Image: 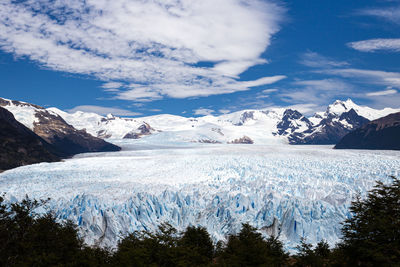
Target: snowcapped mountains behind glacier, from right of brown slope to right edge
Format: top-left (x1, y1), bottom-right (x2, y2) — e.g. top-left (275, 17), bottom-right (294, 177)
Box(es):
top-left (48, 99), bottom-right (400, 144)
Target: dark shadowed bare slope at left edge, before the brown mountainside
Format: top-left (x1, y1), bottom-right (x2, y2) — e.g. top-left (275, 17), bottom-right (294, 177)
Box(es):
top-left (0, 107), bottom-right (60, 172)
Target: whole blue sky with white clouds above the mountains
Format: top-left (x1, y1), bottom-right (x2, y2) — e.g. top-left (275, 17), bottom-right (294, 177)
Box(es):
top-left (0, 0), bottom-right (400, 117)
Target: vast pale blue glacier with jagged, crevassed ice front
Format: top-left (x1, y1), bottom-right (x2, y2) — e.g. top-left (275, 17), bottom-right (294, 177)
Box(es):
top-left (0, 139), bottom-right (400, 251)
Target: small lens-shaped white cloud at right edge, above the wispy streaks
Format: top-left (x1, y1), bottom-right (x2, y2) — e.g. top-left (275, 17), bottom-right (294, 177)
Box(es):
top-left (348, 39), bottom-right (400, 52)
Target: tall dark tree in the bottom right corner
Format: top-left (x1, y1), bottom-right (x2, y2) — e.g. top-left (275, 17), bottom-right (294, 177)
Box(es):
top-left (339, 177), bottom-right (400, 266)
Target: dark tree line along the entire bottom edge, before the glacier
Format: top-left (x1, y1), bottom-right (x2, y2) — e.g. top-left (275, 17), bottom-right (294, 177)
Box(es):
top-left (0, 178), bottom-right (400, 267)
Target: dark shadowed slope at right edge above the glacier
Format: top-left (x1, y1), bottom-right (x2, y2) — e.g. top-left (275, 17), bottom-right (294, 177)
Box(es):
top-left (335, 112), bottom-right (400, 150)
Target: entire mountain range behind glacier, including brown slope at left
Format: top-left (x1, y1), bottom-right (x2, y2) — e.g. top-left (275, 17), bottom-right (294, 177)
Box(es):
top-left (0, 98), bottom-right (400, 148)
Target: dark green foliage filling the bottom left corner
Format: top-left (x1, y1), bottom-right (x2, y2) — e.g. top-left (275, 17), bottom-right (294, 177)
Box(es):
top-left (0, 197), bottom-right (107, 266)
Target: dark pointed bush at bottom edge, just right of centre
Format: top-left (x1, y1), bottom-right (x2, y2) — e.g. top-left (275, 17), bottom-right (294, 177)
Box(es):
top-left (219, 224), bottom-right (287, 266)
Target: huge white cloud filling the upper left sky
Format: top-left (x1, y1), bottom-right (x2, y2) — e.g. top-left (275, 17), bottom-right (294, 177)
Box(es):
top-left (0, 0), bottom-right (284, 101)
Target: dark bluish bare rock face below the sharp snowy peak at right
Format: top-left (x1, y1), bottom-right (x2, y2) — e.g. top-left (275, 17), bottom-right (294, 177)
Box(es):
top-left (289, 109), bottom-right (369, 145)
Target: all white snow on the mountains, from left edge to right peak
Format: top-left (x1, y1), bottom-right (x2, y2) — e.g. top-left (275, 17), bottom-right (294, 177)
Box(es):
top-left (5, 99), bottom-right (400, 145)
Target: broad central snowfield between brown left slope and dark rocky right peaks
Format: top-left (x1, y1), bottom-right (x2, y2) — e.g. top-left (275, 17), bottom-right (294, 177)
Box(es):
top-left (49, 108), bottom-right (287, 144)
